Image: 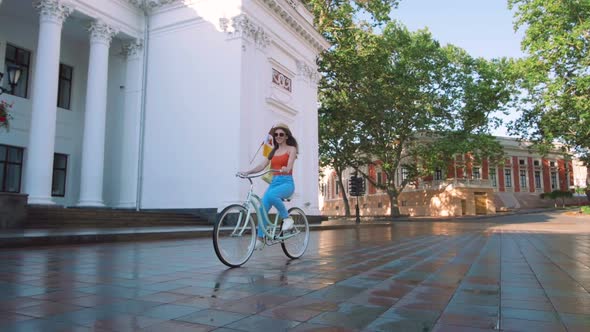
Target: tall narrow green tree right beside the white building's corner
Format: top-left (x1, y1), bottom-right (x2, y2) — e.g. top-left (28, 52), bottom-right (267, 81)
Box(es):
top-left (304, 0), bottom-right (398, 216)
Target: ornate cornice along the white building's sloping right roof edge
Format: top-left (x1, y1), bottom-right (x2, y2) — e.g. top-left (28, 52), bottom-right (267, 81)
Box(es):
top-left (260, 0), bottom-right (330, 53)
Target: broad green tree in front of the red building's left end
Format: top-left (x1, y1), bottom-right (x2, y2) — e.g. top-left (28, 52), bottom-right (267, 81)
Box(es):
top-left (354, 22), bottom-right (511, 216)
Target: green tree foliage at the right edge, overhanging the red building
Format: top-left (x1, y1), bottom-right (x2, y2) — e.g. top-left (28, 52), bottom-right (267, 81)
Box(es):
top-left (508, 0), bottom-right (590, 155)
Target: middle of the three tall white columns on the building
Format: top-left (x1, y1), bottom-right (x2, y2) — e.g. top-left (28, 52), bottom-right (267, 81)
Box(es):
top-left (78, 21), bottom-right (116, 206)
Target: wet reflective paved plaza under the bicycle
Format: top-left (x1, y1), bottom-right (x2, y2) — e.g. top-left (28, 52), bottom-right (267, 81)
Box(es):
top-left (0, 212), bottom-right (590, 332)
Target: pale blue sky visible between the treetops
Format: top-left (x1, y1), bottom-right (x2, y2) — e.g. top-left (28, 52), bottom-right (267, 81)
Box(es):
top-left (390, 0), bottom-right (524, 136)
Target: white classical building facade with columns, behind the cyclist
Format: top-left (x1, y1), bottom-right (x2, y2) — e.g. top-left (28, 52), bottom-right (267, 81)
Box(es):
top-left (0, 0), bottom-right (329, 215)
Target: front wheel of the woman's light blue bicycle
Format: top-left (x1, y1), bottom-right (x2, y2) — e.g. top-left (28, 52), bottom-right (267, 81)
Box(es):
top-left (213, 204), bottom-right (256, 267)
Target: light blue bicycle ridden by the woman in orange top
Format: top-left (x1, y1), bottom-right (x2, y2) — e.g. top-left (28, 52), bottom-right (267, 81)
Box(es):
top-left (213, 170), bottom-right (309, 267)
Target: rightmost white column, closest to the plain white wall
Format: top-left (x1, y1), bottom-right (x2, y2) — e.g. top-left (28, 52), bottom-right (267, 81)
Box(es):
top-left (117, 40), bottom-right (143, 208)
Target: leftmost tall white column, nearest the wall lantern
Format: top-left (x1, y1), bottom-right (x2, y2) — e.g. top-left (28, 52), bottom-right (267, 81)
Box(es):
top-left (25, 0), bottom-right (72, 205)
